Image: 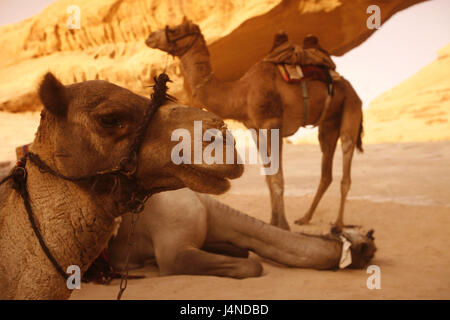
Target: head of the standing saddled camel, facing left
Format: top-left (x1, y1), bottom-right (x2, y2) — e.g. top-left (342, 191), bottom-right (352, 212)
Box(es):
top-left (145, 18), bottom-right (204, 57)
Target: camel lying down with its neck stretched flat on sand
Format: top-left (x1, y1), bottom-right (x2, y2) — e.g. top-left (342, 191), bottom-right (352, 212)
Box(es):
top-left (106, 188), bottom-right (376, 279)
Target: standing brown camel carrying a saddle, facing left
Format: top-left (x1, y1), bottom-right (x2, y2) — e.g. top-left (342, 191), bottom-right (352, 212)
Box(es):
top-left (146, 19), bottom-right (362, 229)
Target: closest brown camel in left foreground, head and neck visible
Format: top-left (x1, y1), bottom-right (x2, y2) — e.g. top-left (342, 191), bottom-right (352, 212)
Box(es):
top-left (0, 73), bottom-right (243, 299)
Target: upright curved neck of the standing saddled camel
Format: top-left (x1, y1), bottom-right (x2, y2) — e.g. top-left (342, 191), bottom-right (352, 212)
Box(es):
top-left (180, 36), bottom-right (246, 120)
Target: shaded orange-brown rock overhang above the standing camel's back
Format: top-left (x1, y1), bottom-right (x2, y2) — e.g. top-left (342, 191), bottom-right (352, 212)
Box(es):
top-left (209, 0), bottom-right (428, 80)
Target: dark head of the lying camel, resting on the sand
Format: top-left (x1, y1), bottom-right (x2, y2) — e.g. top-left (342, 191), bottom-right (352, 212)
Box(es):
top-left (342, 229), bottom-right (377, 269)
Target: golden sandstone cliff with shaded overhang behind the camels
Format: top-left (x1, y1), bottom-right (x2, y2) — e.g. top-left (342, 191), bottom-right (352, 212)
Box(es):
top-left (0, 0), bottom-right (422, 112)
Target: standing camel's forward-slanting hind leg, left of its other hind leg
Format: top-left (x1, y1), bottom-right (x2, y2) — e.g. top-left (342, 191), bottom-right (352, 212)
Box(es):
top-left (295, 122), bottom-right (339, 225)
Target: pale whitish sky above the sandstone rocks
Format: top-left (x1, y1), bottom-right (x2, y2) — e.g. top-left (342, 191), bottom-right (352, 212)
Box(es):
top-left (0, 0), bottom-right (450, 107)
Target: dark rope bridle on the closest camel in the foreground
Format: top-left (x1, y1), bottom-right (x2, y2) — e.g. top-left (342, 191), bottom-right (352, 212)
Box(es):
top-left (0, 73), bottom-right (175, 299)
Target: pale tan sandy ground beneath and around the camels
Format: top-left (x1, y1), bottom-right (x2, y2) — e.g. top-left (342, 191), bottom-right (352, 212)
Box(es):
top-left (66, 142), bottom-right (450, 299)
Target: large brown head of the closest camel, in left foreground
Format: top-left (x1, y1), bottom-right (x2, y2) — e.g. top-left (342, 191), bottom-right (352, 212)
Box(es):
top-left (32, 73), bottom-right (243, 200)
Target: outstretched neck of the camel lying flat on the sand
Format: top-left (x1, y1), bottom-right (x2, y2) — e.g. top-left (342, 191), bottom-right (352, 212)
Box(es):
top-left (197, 194), bottom-right (340, 269)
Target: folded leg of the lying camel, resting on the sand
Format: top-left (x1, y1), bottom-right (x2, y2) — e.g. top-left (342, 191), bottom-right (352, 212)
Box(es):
top-left (158, 246), bottom-right (262, 279)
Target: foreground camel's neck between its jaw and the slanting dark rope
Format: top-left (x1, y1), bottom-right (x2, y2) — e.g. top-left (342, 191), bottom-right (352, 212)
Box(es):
top-left (26, 163), bottom-right (118, 273)
